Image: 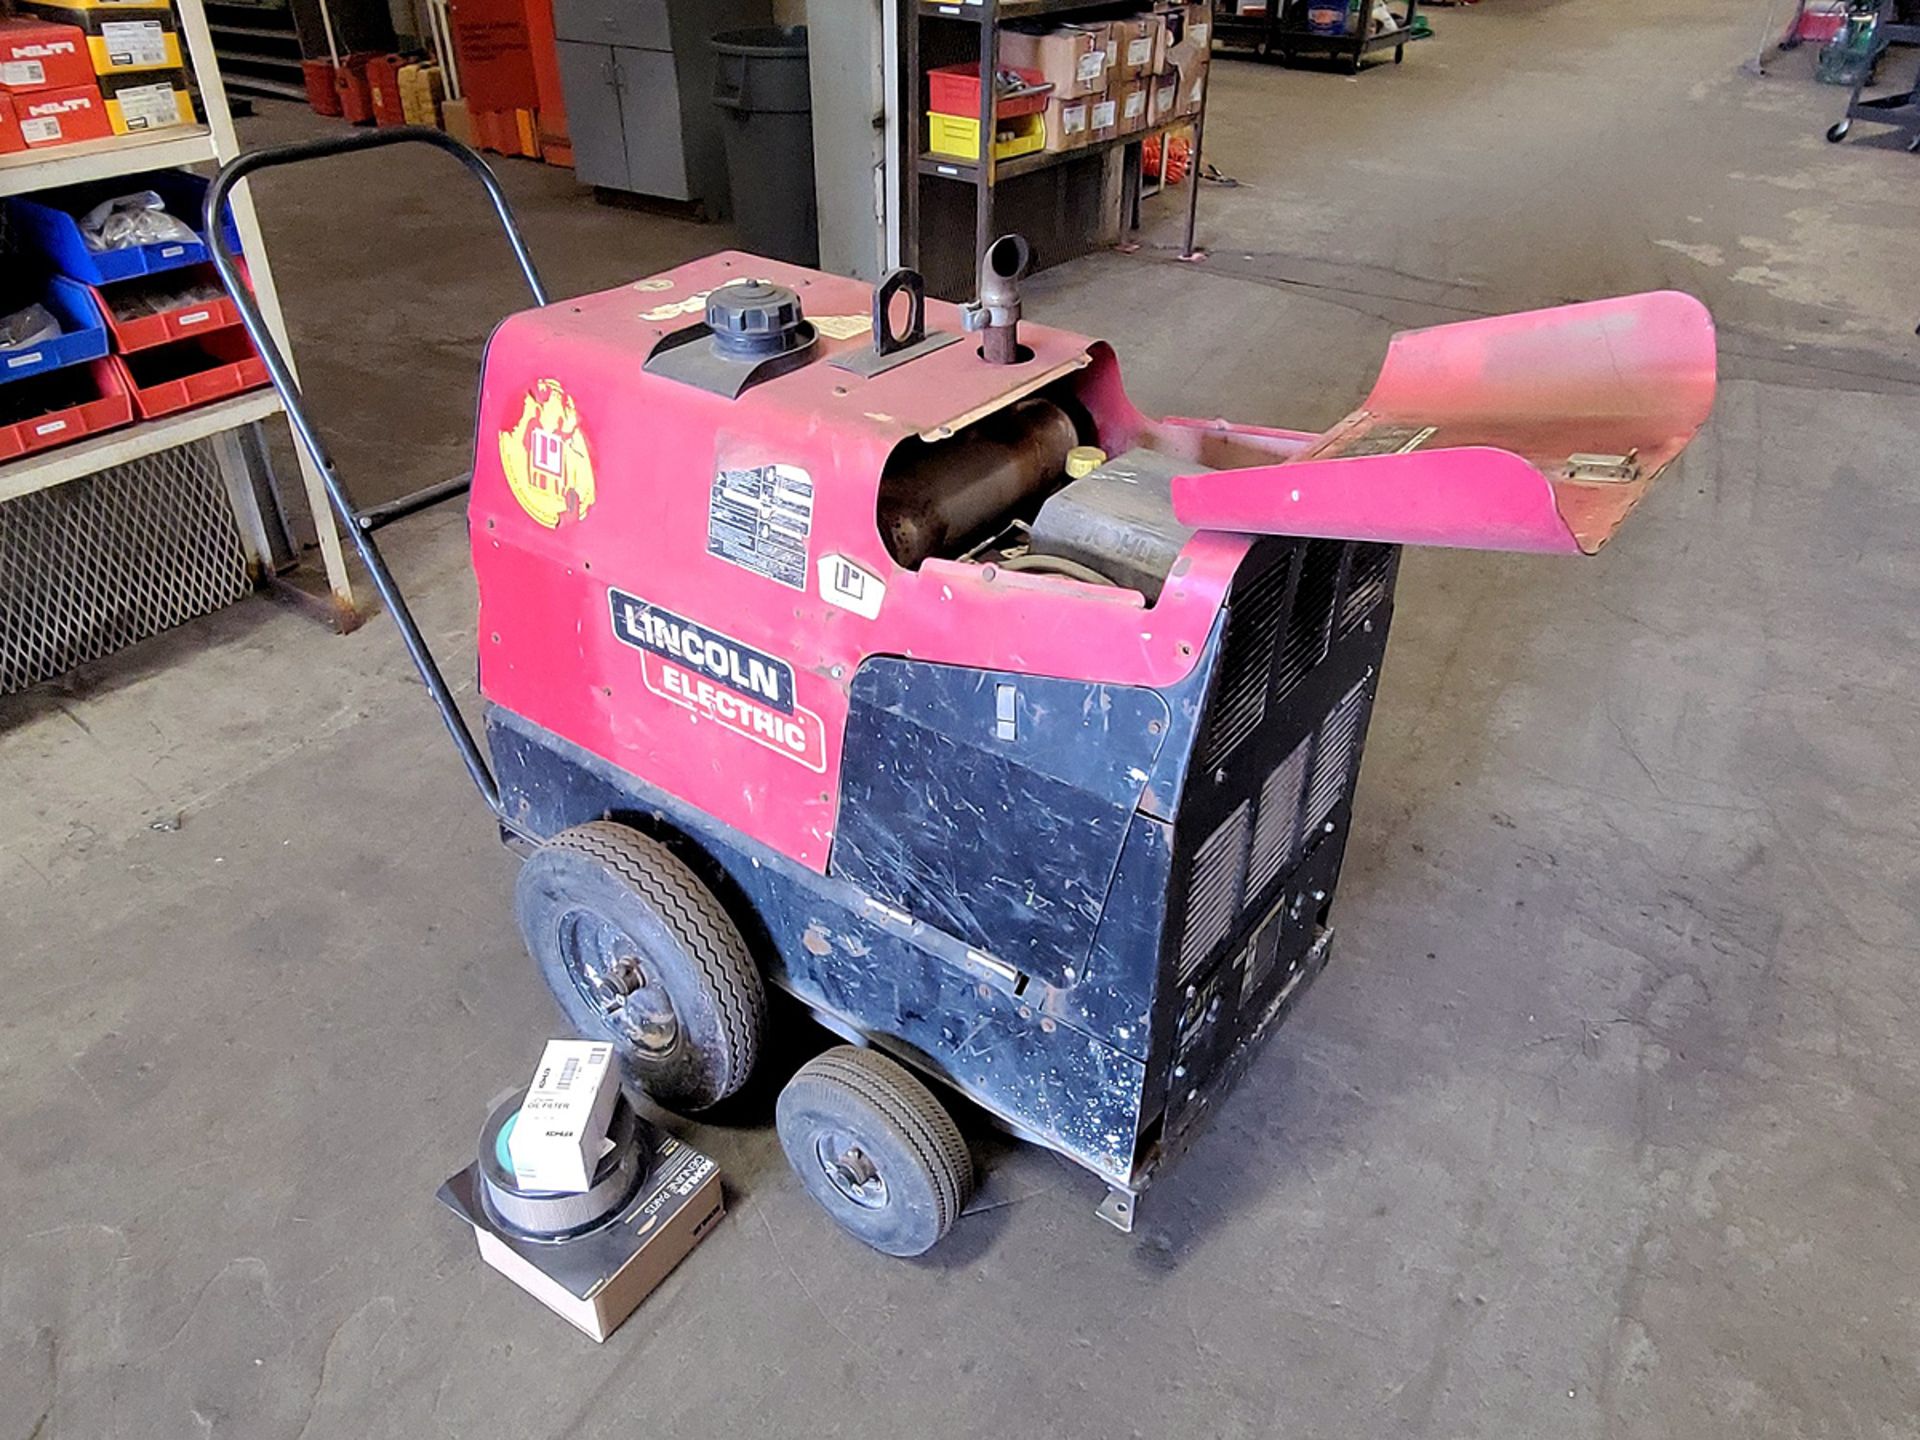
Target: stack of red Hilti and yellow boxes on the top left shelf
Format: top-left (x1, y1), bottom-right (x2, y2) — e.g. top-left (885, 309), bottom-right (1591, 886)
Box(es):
top-left (0, 0), bottom-right (194, 146)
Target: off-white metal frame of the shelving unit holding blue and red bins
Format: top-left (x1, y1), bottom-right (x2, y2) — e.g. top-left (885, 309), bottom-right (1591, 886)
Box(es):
top-left (0, 0), bottom-right (357, 695)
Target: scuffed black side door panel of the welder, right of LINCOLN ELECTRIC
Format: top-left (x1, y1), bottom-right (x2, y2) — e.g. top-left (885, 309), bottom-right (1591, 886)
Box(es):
top-left (828, 659), bottom-right (1167, 985)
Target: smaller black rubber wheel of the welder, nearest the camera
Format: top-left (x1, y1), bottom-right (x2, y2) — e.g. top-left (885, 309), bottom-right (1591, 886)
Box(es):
top-left (776, 1044), bottom-right (973, 1256)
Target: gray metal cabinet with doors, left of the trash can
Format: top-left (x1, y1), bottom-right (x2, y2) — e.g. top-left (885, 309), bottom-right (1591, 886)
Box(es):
top-left (553, 0), bottom-right (772, 217)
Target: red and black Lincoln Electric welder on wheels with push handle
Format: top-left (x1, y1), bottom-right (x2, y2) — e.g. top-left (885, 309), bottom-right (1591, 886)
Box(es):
top-left (207, 131), bottom-right (1715, 1254)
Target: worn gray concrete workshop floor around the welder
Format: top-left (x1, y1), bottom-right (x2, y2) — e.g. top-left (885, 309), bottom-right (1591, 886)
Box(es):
top-left (0, 0), bottom-right (1920, 1440)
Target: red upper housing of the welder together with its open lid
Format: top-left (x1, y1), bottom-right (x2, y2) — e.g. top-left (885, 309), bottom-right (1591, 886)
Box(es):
top-left (470, 253), bottom-right (1715, 872)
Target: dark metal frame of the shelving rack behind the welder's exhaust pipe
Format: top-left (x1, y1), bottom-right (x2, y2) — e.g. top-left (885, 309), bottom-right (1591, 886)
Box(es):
top-left (899, 0), bottom-right (1206, 300)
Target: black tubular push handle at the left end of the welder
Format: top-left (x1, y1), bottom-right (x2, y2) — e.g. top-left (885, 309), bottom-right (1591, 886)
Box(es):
top-left (202, 125), bottom-right (547, 820)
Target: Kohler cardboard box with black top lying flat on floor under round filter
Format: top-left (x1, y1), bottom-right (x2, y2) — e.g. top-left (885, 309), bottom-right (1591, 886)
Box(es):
top-left (440, 1135), bottom-right (726, 1342)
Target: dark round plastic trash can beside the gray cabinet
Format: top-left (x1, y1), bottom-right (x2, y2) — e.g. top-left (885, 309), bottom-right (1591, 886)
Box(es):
top-left (712, 25), bottom-right (820, 265)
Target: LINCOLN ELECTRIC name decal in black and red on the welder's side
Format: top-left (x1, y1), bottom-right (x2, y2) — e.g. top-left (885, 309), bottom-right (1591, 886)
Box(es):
top-left (607, 589), bottom-right (828, 774)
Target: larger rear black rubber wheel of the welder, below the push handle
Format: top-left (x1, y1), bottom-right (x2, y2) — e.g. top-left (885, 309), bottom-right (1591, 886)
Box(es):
top-left (513, 820), bottom-right (766, 1110)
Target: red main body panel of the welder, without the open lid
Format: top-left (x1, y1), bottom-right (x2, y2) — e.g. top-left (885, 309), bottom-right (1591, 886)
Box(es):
top-left (470, 253), bottom-right (1244, 872)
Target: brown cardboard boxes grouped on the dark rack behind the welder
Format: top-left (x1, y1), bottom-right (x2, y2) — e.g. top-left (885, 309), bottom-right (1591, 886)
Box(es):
top-left (1000, 0), bottom-right (1213, 152)
